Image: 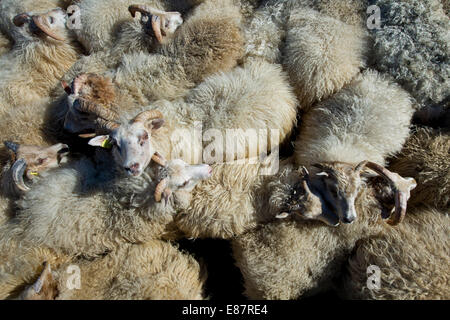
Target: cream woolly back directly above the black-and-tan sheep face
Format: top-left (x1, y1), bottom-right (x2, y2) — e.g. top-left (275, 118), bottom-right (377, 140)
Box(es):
top-left (295, 70), bottom-right (414, 165)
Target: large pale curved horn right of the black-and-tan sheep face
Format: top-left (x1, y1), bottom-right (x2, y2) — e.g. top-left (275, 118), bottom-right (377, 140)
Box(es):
top-left (366, 161), bottom-right (417, 225)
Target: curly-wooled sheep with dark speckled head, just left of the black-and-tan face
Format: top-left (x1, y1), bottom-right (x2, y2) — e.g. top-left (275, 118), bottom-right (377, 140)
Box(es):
top-left (175, 154), bottom-right (409, 239)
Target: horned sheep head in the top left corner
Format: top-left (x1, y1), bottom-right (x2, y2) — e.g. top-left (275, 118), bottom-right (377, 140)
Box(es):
top-left (13, 8), bottom-right (67, 41)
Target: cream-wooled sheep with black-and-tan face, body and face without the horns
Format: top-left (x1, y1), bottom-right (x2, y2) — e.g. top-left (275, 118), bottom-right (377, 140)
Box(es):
top-left (295, 70), bottom-right (414, 223)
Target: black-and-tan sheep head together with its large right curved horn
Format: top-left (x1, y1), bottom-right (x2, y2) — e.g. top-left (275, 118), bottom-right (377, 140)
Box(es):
top-left (309, 161), bottom-right (416, 225)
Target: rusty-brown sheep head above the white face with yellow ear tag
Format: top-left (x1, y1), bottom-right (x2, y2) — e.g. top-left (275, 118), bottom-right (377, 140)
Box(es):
top-left (62, 73), bottom-right (118, 138)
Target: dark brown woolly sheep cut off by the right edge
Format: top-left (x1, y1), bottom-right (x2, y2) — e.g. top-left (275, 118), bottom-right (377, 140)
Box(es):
top-left (389, 128), bottom-right (450, 211)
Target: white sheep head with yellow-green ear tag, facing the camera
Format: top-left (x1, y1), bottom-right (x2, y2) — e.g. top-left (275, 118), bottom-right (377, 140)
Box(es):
top-left (89, 110), bottom-right (165, 177)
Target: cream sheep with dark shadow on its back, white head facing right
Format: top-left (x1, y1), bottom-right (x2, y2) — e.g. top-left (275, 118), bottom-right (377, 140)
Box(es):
top-left (0, 145), bottom-right (211, 257)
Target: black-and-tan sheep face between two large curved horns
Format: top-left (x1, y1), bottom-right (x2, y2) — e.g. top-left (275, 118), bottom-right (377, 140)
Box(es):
top-left (311, 162), bottom-right (365, 223)
